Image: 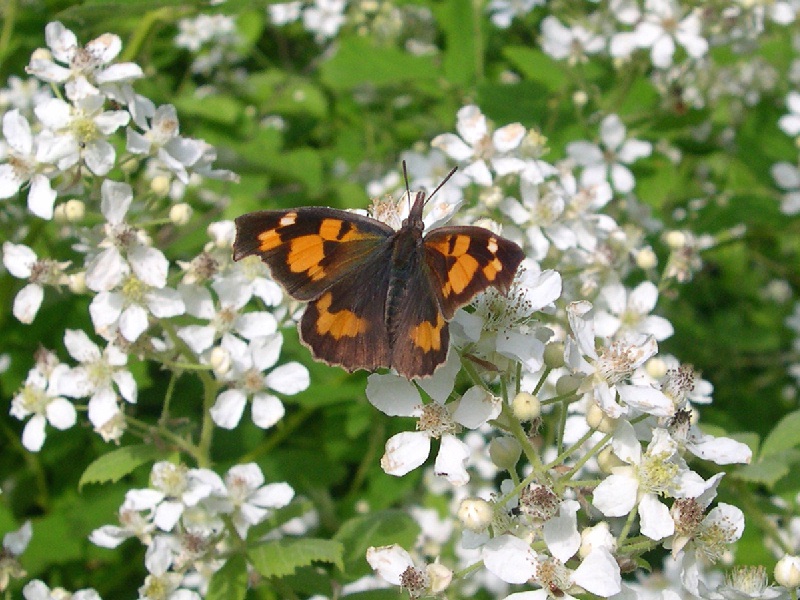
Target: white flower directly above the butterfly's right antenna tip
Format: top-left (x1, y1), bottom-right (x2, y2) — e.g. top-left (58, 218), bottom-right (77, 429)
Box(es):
top-left (431, 105), bottom-right (527, 186)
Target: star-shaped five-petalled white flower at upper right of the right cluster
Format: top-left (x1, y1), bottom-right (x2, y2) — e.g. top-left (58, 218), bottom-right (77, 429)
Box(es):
top-left (567, 115), bottom-right (653, 193)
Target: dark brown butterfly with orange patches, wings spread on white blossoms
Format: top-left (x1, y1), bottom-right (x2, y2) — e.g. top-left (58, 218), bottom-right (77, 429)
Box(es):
top-left (233, 165), bottom-right (524, 379)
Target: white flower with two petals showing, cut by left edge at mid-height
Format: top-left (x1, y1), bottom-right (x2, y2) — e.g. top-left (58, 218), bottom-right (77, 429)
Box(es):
top-left (3, 242), bottom-right (69, 323)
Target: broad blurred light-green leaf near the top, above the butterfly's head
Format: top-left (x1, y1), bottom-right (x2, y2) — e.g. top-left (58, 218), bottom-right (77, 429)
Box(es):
top-left (321, 38), bottom-right (438, 89)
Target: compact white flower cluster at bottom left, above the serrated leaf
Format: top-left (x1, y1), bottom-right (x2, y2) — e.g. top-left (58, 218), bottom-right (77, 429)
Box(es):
top-left (90, 462), bottom-right (294, 600)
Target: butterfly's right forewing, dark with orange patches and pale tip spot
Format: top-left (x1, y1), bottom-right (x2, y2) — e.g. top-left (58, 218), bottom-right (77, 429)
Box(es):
top-left (423, 227), bottom-right (525, 320)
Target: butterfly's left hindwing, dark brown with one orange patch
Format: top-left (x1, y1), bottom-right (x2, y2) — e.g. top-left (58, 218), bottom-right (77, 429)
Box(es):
top-left (300, 244), bottom-right (392, 371)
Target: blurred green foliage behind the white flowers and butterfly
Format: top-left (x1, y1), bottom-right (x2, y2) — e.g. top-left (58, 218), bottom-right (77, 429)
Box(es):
top-left (0, 0), bottom-right (800, 598)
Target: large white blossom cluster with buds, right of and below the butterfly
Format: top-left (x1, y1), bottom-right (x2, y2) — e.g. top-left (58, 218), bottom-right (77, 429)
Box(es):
top-left (356, 106), bottom-right (751, 600)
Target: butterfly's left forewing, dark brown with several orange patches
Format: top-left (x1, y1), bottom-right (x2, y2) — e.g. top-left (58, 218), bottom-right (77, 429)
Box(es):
top-left (233, 207), bottom-right (394, 301)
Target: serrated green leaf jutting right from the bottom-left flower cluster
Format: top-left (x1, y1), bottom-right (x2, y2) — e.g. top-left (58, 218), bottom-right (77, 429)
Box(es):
top-left (248, 538), bottom-right (344, 577)
